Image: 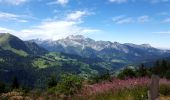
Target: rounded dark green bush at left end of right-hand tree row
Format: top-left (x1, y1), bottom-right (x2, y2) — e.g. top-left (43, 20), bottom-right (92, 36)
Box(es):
top-left (117, 68), bottom-right (137, 79)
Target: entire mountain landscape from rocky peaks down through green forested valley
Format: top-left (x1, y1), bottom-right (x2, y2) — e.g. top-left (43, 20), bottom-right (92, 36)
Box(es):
top-left (0, 33), bottom-right (170, 88)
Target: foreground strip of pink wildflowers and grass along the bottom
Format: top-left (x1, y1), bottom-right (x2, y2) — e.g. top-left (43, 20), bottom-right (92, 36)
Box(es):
top-left (0, 78), bottom-right (170, 100)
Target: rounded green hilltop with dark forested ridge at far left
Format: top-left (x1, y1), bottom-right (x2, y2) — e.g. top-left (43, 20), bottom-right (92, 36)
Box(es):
top-left (0, 33), bottom-right (47, 56)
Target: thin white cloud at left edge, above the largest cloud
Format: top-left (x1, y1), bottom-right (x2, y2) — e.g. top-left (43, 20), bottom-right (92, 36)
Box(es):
top-left (0, 12), bottom-right (28, 22)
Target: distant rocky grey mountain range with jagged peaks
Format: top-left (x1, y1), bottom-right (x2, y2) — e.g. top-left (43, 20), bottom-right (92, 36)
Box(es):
top-left (30, 35), bottom-right (170, 64)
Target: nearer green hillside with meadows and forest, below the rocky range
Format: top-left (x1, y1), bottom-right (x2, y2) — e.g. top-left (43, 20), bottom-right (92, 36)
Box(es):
top-left (0, 33), bottom-right (109, 88)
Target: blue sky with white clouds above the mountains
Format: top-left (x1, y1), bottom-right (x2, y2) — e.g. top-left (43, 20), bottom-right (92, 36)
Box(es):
top-left (0, 0), bottom-right (170, 49)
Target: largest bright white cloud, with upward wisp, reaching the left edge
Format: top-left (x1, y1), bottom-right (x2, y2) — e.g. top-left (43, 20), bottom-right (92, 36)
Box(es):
top-left (0, 11), bottom-right (100, 40)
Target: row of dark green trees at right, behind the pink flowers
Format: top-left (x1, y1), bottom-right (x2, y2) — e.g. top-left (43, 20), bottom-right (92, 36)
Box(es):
top-left (118, 59), bottom-right (170, 79)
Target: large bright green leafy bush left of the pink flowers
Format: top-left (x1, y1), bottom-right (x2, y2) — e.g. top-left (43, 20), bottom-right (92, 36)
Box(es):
top-left (56, 74), bottom-right (82, 95)
